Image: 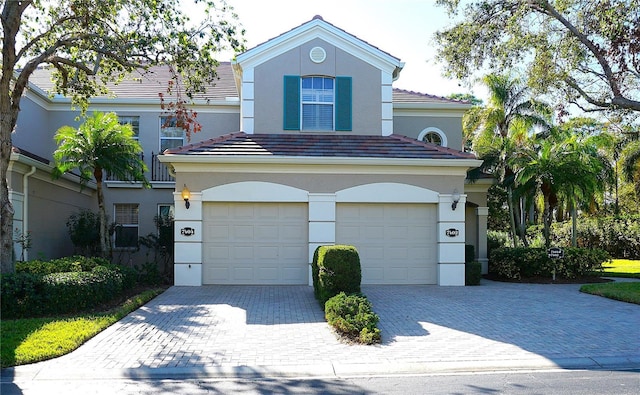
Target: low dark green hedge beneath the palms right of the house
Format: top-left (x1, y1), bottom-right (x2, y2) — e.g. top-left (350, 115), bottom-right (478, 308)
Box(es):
top-left (489, 247), bottom-right (611, 279)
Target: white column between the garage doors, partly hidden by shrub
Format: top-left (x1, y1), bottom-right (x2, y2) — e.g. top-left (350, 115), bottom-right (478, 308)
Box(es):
top-left (309, 193), bottom-right (336, 286)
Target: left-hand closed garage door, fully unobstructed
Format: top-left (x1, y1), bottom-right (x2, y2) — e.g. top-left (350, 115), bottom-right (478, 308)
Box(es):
top-left (203, 203), bottom-right (309, 284)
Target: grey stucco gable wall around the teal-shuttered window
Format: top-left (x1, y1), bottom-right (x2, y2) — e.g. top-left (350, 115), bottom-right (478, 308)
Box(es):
top-left (254, 39), bottom-right (382, 135)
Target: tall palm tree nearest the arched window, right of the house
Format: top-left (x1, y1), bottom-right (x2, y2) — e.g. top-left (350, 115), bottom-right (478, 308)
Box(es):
top-left (463, 74), bottom-right (551, 246)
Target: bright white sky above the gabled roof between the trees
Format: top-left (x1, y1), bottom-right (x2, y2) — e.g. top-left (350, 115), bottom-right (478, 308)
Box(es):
top-left (220, 0), bottom-right (484, 98)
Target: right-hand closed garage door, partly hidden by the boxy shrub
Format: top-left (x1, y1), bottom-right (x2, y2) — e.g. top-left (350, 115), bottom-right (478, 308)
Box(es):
top-left (336, 203), bottom-right (437, 284)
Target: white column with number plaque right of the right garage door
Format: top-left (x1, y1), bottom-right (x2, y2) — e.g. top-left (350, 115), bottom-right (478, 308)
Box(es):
top-left (438, 194), bottom-right (467, 286)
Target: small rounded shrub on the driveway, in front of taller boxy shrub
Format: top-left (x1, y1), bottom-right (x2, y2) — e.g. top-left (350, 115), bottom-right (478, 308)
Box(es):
top-left (324, 292), bottom-right (381, 344)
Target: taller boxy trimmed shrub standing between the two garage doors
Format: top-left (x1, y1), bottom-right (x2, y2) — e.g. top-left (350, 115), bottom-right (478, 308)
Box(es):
top-left (312, 245), bottom-right (362, 308)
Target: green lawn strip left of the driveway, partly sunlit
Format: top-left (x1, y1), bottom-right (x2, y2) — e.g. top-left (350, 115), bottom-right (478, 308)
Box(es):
top-left (0, 289), bottom-right (164, 368)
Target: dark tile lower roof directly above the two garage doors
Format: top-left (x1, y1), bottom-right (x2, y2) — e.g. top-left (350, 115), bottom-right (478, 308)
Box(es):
top-left (164, 132), bottom-right (476, 159)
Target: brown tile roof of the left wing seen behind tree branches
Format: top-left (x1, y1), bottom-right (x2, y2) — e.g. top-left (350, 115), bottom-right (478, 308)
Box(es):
top-left (29, 62), bottom-right (238, 101)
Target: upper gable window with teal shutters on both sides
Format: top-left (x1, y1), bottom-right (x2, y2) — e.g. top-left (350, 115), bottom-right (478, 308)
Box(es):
top-left (283, 75), bottom-right (352, 131)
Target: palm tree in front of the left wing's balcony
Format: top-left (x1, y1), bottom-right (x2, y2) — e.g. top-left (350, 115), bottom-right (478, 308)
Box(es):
top-left (53, 112), bottom-right (149, 257)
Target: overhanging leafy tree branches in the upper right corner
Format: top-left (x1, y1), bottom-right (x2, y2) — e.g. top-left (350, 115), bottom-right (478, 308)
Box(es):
top-left (435, 0), bottom-right (640, 111)
